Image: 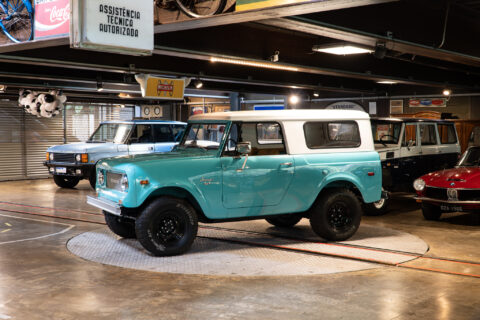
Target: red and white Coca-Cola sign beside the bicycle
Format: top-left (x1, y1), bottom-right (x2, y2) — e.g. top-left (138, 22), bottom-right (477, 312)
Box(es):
top-left (35, 0), bottom-right (70, 40)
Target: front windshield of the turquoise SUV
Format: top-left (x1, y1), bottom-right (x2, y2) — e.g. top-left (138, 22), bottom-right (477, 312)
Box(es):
top-left (177, 123), bottom-right (226, 150)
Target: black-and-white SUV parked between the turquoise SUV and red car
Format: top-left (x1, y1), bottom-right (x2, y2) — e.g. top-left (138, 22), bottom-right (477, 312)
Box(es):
top-left (365, 118), bottom-right (460, 215)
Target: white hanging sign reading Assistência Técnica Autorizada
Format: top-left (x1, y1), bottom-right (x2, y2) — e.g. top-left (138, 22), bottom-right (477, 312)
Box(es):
top-left (70, 0), bottom-right (153, 55)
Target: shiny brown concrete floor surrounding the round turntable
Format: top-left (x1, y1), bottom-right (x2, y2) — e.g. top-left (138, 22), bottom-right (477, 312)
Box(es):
top-left (0, 179), bottom-right (480, 320)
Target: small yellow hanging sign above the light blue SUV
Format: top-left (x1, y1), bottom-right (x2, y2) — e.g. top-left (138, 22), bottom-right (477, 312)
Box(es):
top-left (135, 74), bottom-right (190, 100)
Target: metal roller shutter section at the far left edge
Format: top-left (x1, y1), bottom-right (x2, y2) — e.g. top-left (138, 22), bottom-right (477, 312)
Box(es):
top-left (0, 103), bottom-right (25, 181)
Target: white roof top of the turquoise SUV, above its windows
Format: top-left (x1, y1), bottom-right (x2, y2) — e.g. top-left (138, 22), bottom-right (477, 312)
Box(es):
top-left (189, 109), bottom-right (370, 121)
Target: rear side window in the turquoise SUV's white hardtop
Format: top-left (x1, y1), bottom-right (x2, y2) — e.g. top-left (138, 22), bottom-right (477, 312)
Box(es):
top-left (303, 121), bottom-right (361, 149)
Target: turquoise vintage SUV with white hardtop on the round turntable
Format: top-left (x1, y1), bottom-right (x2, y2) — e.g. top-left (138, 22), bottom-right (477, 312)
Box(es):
top-left (87, 110), bottom-right (382, 256)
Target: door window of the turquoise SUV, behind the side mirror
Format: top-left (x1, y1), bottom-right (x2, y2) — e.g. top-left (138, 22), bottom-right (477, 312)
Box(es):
top-left (223, 122), bottom-right (286, 156)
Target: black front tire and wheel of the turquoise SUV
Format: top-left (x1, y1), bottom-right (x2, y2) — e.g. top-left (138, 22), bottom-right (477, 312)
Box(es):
top-left (135, 197), bottom-right (198, 256)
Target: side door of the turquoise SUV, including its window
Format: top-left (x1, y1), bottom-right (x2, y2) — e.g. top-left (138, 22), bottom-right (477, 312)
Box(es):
top-left (221, 123), bottom-right (295, 209)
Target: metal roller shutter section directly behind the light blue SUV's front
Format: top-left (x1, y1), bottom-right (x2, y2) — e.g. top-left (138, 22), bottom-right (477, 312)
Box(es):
top-left (25, 114), bottom-right (63, 178)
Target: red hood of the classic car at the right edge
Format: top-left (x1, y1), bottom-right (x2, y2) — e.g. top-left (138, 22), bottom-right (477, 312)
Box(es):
top-left (421, 167), bottom-right (480, 189)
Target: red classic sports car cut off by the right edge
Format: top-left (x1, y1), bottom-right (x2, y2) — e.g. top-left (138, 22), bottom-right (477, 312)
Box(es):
top-left (413, 147), bottom-right (480, 220)
